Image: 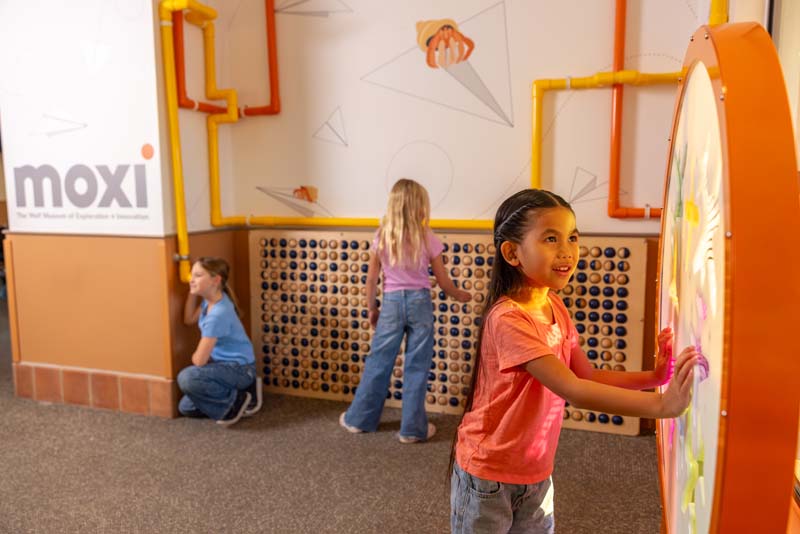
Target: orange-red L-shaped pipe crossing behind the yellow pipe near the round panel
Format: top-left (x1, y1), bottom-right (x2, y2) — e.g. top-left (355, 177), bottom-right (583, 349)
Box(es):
top-left (608, 0), bottom-right (661, 219)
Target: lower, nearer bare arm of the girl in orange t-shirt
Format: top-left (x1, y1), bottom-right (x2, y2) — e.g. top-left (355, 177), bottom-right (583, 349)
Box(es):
top-left (525, 347), bottom-right (700, 419)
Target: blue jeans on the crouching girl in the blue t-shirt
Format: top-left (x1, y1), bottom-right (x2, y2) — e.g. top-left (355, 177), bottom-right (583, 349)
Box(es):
top-left (178, 362), bottom-right (256, 420)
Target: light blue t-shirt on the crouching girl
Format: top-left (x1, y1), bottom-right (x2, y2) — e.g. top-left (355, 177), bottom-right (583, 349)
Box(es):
top-left (199, 293), bottom-right (256, 365)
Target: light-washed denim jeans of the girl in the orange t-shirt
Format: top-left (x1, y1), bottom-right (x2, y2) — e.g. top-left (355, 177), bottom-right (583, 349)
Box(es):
top-left (450, 463), bottom-right (555, 534)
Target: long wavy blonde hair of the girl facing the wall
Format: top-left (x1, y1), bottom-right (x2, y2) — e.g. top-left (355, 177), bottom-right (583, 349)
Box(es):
top-left (378, 178), bottom-right (431, 267)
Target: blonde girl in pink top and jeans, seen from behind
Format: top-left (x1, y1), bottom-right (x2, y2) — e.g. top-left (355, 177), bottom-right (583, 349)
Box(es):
top-left (339, 178), bottom-right (472, 443)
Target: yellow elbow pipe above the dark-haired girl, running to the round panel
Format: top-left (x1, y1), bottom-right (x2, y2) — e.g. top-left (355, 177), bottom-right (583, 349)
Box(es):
top-left (531, 70), bottom-right (683, 189)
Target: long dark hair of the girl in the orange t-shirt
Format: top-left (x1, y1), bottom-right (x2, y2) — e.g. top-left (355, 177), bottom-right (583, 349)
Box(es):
top-left (447, 189), bottom-right (574, 483)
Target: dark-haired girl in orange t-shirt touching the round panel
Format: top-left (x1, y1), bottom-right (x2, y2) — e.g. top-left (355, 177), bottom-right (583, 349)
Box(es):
top-left (450, 189), bottom-right (707, 533)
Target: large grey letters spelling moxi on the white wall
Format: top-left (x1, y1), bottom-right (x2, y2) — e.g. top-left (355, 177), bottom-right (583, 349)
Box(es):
top-left (14, 164), bottom-right (147, 208)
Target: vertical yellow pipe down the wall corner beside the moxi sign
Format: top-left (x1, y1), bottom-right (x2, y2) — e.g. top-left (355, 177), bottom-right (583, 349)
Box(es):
top-left (159, 0), bottom-right (192, 283)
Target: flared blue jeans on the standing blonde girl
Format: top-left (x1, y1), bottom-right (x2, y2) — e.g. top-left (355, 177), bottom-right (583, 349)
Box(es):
top-left (344, 289), bottom-right (433, 440)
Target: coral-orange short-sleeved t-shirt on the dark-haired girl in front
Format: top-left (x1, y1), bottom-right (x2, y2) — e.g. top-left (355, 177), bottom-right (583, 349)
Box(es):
top-left (456, 291), bottom-right (578, 484)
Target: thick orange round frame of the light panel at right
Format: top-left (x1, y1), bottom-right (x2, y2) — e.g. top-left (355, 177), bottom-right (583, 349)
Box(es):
top-left (656, 23), bottom-right (800, 533)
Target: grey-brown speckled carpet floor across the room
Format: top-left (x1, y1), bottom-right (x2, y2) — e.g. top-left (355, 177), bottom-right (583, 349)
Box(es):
top-left (0, 302), bottom-right (661, 534)
